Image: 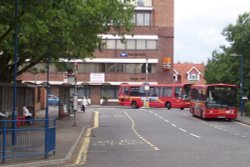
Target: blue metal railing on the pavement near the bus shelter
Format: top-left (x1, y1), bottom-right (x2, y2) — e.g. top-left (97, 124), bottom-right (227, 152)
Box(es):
top-left (0, 119), bottom-right (56, 163)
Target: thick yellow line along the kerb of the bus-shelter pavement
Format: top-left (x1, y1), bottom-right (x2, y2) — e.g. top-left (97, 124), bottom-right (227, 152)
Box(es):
top-left (74, 112), bottom-right (99, 165)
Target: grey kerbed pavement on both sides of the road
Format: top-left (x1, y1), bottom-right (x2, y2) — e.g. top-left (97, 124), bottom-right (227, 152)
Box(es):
top-left (0, 106), bottom-right (250, 167)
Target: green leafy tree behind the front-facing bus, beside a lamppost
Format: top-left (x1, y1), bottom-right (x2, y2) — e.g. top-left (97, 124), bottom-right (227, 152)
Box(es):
top-left (205, 13), bottom-right (250, 96)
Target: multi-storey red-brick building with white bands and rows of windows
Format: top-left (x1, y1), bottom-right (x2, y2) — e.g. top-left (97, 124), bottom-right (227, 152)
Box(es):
top-left (18, 0), bottom-right (174, 104)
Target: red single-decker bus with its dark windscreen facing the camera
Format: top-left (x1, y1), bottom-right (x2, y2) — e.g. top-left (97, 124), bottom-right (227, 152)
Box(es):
top-left (190, 84), bottom-right (238, 120)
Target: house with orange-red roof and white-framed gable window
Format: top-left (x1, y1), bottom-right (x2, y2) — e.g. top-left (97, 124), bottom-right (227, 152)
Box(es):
top-left (173, 63), bottom-right (206, 84)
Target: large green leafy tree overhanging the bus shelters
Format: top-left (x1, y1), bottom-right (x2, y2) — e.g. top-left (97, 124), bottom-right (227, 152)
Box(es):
top-left (0, 0), bottom-right (134, 82)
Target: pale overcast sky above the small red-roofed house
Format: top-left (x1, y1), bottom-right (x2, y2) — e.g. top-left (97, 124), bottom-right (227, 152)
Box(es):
top-left (174, 0), bottom-right (250, 64)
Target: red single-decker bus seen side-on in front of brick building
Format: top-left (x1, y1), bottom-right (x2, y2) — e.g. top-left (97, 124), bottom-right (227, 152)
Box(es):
top-left (118, 84), bottom-right (191, 110)
